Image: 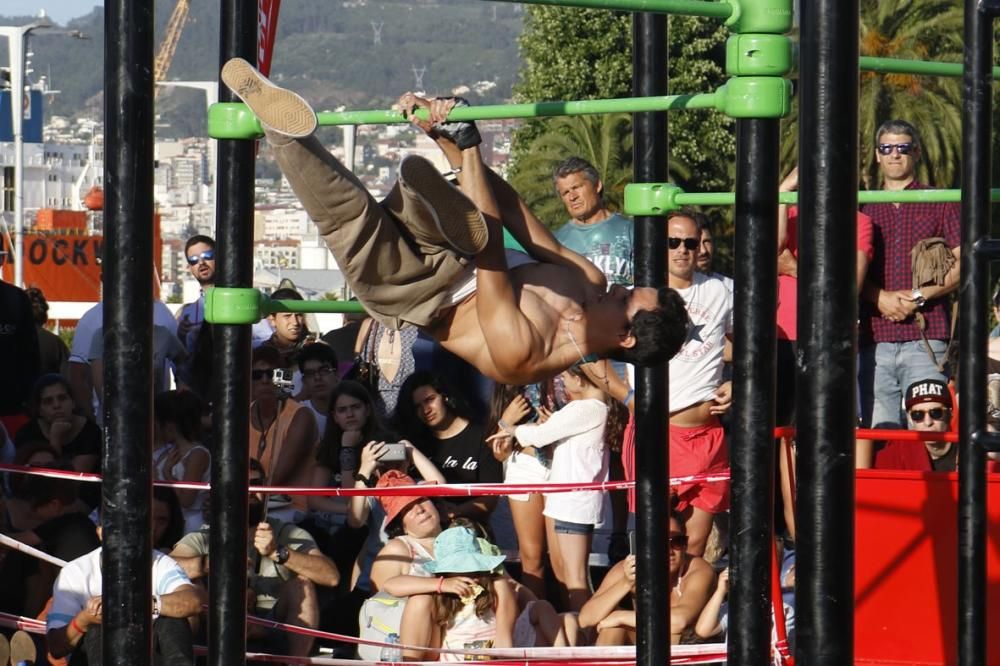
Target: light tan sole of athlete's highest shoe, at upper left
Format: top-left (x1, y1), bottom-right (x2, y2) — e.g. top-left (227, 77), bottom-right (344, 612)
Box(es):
top-left (222, 58), bottom-right (316, 139)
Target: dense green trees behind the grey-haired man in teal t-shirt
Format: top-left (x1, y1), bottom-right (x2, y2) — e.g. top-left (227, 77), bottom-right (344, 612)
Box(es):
top-left (511, 6), bottom-right (735, 230)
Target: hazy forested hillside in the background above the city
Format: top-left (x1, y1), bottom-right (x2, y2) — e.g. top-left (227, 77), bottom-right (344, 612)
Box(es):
top-left (0, 0), bottom-right (523, 136)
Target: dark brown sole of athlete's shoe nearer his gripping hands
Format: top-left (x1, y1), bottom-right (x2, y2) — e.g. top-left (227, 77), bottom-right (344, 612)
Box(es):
top-left (399, 156), bottom-right (489, 256)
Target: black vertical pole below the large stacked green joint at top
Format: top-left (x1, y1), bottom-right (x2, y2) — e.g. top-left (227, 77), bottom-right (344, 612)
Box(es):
top-left (729, 119), bottom-right (778, 665)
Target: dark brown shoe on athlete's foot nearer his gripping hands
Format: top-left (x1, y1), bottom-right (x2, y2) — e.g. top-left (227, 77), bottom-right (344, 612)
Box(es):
top-left (383, 155), bottom-right (489, 257)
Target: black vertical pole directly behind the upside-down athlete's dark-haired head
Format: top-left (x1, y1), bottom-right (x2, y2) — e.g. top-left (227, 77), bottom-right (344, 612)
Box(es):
top-left (632, 12), bottom-right (670, 666)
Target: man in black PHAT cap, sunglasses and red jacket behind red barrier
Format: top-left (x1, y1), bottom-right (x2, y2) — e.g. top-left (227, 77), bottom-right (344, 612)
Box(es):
top-left (875, 379), bottom-right (958, 472)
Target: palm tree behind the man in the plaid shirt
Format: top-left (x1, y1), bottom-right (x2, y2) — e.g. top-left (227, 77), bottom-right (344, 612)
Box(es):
top-left (781, 0), bottom-right (963, 188)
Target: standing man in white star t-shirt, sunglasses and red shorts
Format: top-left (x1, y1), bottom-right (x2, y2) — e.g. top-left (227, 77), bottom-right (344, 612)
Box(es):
top-left (667, 210), bottom-right (733, 555)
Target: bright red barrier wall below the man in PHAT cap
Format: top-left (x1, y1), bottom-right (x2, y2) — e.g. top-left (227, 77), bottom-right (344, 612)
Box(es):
top-left (855, 470), bottom-right (1000, 665)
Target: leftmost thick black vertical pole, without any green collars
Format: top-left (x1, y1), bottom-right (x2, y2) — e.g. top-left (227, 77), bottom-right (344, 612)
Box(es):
top-left (101, 0), bottom-right (154, 666)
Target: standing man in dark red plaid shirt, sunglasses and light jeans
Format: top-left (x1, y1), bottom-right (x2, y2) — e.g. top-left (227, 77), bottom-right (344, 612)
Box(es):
top-left (859, 120), bottom-right (960, 428)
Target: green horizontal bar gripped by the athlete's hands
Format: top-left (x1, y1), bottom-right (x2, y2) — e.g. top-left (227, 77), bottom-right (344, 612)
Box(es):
top-left (316, 93), bottom-right (719, 125)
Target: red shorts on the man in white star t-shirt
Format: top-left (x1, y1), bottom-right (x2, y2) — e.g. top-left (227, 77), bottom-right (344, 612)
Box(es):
top-left (670, 420), bottom-right (729, 513)
